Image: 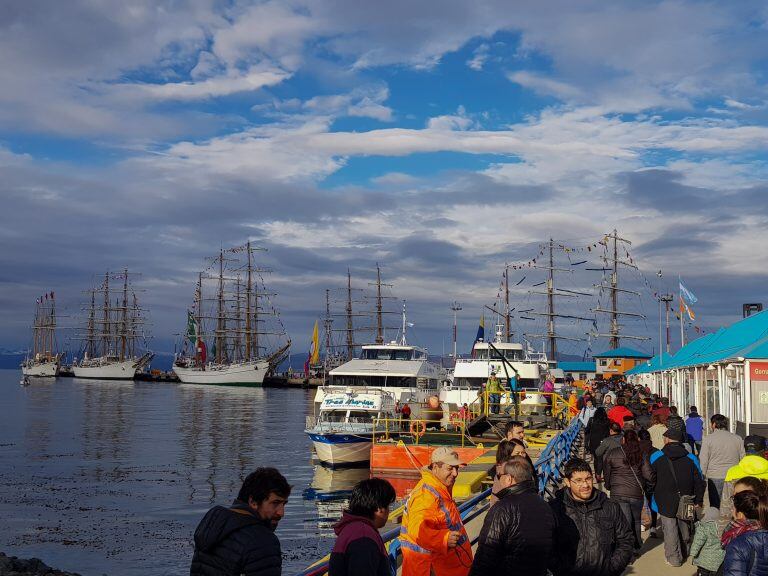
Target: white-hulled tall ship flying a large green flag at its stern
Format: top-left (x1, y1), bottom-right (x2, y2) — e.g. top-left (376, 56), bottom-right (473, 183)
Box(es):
top-left (173, 242), bottom-right (291, 386)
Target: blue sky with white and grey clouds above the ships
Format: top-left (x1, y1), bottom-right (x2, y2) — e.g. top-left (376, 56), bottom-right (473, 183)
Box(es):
top-left (0, 0), bottom-right (768, 360)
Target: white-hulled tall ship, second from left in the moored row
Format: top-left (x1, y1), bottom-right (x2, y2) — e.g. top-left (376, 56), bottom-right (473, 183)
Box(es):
top-left (72, 270), bottom-right (154, 380)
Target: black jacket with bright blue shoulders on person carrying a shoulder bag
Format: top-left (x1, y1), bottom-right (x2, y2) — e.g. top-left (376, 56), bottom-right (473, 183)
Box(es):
top-left (651, 442), bottom-right (707, 518)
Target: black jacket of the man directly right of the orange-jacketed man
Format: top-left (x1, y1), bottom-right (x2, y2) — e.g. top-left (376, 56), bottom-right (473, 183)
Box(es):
top-left (469, 482), bottom-right (555, 576)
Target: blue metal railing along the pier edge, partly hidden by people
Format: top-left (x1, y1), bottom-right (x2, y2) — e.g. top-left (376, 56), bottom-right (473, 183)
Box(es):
top-left (296, 418), bottom-right (582, 576)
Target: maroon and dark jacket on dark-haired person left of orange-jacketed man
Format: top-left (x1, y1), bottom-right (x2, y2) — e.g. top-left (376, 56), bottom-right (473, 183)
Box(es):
top-left (328, 511), bottom-right (391, 576)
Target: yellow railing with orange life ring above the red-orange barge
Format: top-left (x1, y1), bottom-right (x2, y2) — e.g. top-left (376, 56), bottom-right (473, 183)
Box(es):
top-left (373, 418), bottom-right (469, 448)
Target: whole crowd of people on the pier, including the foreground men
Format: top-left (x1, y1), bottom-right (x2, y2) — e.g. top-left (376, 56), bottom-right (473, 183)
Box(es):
top-left (190, 383), bottom-right (768, 576)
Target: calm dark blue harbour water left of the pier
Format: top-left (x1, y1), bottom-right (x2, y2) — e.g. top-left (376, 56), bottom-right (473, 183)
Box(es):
top-left (0, 370), bottom-right (368, 576)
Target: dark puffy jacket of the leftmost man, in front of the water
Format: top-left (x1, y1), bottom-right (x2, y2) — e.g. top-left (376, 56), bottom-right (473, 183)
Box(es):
top-left (189, 500), bottom-right (282, 576)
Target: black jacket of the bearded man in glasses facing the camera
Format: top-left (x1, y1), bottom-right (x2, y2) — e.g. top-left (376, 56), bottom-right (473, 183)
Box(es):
top-left (549, 488), bottom-right (635, 576)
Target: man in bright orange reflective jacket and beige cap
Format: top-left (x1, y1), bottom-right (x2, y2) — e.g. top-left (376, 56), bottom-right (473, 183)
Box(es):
top-left (400, 446), bottom-right (472, 576)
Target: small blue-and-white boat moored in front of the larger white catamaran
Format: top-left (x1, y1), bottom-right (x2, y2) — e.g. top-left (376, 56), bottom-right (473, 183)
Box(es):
top-left (306, 388), bottom-right (395, 467)
